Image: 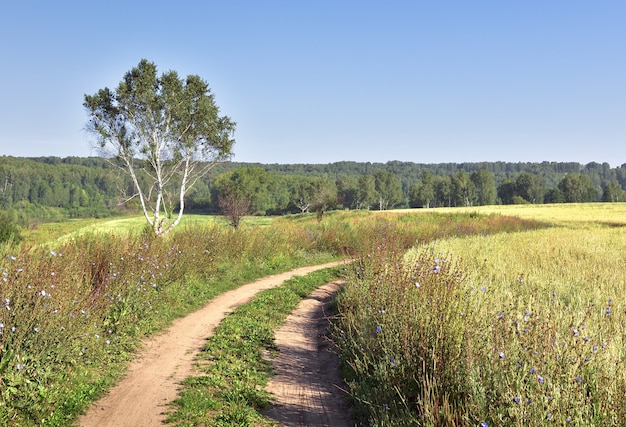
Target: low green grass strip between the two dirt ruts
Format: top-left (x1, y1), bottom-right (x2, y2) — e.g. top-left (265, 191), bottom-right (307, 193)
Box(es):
top-left (167, 267), bottom-right (345, 426)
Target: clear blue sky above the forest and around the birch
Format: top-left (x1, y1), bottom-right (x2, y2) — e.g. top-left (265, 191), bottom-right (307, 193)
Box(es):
top-left (0, 0), bottom-right (626, 167)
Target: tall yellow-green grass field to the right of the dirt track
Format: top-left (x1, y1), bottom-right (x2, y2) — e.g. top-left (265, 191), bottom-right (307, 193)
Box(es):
top-left (334, 204), bottom-right (626, 426)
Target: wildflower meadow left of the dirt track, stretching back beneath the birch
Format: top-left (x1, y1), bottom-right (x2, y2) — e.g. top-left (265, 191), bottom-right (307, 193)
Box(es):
top-left (0, 208), bottom-right (538, 426)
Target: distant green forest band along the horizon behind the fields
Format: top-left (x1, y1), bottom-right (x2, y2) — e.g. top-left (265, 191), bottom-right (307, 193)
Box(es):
top-left (0, 156), bottom-right (626, 225)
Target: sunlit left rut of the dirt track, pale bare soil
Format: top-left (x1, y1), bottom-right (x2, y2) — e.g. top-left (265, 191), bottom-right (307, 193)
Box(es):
top-left (77, 263), bottom-right (340, 427)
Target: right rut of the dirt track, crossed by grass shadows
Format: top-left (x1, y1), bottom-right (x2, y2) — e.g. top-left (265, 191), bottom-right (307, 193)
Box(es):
top-left (264, 282), bottom-right (354, 427)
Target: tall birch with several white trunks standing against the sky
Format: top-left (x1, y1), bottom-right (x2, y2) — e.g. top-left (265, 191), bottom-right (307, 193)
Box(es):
top-left (83, 59), bottom-right (235, 236)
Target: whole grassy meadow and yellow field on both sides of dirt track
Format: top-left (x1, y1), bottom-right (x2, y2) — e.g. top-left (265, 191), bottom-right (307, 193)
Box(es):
top-left (0, 204), bottom-right (626, 426)
